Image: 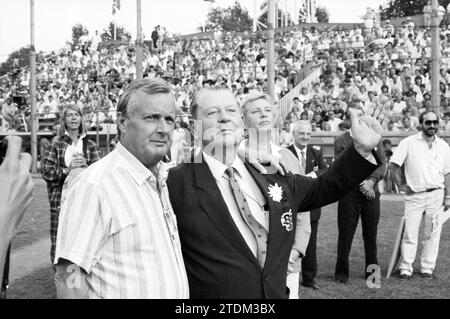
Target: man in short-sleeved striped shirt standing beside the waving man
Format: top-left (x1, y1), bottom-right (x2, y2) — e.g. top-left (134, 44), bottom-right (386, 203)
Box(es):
top-left (54, 79), bottom-right (189, 298)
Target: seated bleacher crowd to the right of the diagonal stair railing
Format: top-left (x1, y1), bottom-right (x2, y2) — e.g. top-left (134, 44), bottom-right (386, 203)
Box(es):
top-left (285, 19), bottom-right (450, 132)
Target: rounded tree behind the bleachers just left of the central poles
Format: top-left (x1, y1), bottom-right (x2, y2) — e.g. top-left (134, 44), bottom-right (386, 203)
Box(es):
top-left (207, 1), bottom-right (253, 32)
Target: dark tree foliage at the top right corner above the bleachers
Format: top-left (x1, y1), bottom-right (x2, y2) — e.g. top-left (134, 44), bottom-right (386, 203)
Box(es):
top-left (381, 0), bottom-right (450, 19)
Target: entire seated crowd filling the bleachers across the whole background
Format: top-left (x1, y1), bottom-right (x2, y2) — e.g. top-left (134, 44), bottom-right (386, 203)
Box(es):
top-left (0, 20), bottom-right (450, 136)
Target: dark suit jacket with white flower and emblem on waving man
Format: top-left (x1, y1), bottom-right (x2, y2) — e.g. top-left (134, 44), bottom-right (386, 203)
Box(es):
top-left (167, 147), bottom-right (378, 299)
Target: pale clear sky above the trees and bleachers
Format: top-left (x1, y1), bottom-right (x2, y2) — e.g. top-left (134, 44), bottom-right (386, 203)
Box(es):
top-left (0, 0), bottom-right (386, 63)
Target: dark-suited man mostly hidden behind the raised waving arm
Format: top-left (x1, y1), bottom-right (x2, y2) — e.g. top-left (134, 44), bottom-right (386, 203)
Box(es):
top-left (334, 104), bottom-right (386, 284)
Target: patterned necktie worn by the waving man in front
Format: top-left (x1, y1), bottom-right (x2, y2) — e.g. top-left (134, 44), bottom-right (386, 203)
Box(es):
top-left (226, 167), bottom-right (267, 268)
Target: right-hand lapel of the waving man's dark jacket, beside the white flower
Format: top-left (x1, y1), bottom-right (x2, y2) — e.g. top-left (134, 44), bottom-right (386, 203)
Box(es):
top-left (245, 163), bottom-right (288, 271)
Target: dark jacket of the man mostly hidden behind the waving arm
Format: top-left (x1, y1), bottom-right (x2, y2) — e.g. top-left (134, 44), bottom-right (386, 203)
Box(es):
top-left (334, 131), bottom-right (387, 196)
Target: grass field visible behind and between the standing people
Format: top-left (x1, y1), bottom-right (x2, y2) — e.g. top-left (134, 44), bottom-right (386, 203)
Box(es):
top-left (8, 178), bottom-right (450, 299)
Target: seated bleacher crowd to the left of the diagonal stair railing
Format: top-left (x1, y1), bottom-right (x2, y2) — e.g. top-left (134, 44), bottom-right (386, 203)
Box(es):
top-left (0, 24), bottom-right (330, 131)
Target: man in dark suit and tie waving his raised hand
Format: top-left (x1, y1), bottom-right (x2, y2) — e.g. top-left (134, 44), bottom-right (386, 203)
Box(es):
top-left (167, 88), bottom-right (381, 299)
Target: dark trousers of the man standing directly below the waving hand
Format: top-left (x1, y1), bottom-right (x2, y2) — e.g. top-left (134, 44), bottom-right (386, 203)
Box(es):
top-left (335, 191), bottom-right (380, 278)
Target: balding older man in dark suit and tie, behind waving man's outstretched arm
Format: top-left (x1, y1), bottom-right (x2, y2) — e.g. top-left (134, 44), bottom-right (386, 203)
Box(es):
top-left (288, 121), bottom-right (328, 290)
